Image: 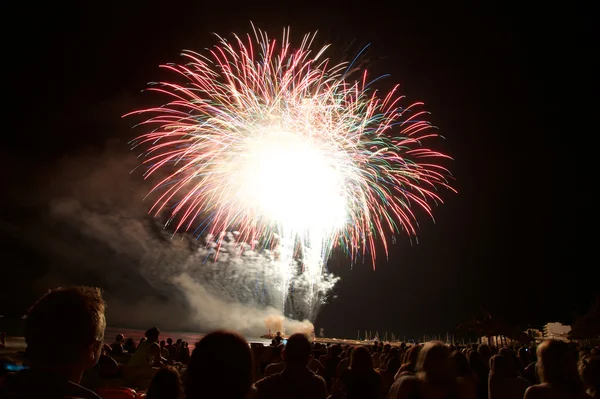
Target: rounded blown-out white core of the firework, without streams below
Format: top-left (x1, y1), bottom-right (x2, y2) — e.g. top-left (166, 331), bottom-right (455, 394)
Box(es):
top-left (238, 128), bottom-right (347, 234)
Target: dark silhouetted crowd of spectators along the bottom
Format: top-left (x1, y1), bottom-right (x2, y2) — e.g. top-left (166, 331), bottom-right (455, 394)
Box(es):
top-left (0, 287), bottom-right (600, 399)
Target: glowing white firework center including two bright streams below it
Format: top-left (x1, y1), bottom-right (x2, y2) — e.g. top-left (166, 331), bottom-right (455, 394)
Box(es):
top-left (231, 126), bottom-right (348, 316)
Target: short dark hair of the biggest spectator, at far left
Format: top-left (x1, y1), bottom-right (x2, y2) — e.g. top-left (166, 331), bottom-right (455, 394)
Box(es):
top-left (25, 287), bottom-right (106, 364)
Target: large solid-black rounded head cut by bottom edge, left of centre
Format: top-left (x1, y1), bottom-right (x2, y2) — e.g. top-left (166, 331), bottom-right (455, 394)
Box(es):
top-left (185, 331), bottom-right (254, 399)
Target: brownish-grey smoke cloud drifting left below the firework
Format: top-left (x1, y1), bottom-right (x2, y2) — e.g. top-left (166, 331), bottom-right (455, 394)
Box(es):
top-left (4, 142), bottom-right (337, 336)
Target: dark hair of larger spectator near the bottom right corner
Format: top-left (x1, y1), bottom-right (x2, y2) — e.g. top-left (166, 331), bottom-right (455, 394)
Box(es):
top-left (537, 339), bottom-right (584, 393)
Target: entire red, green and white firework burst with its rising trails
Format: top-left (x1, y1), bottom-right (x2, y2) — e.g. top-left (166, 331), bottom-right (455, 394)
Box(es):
top-left (128, 25), bottom-right (452, 322)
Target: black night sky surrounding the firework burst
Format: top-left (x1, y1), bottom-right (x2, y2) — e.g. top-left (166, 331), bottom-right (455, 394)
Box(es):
top-left (0, 1), bottom-right (598, 336)
